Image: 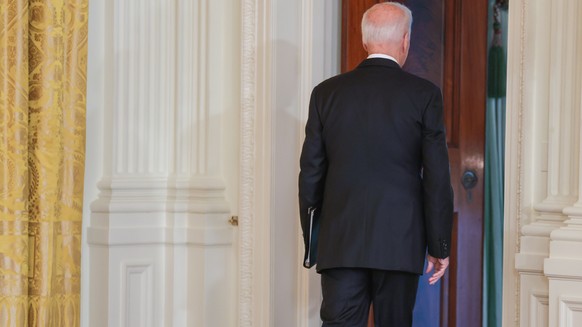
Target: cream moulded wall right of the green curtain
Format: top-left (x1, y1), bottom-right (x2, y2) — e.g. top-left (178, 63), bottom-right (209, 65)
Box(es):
top-left (503, 0), bottom-right (582, 327)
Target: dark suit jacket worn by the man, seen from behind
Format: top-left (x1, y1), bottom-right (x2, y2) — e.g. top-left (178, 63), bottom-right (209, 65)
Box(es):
top-left (299, 58), bottom-right (453, 274)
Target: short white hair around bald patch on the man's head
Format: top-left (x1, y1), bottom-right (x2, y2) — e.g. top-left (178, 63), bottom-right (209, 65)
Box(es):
top-left (362, 2), bottom-right (412, 44)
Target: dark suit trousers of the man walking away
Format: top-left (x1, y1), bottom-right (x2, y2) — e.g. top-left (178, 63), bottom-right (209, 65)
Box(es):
top-left (320, 268), bottom-right (419, 327)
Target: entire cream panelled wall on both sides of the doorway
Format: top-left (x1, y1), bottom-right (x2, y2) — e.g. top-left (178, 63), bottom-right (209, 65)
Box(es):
top-left (82, 0), bottom-right (582, 326)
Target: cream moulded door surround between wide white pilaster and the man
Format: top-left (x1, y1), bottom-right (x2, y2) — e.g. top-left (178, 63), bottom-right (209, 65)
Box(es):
top-left (239, 0), bottom-right (340, 327)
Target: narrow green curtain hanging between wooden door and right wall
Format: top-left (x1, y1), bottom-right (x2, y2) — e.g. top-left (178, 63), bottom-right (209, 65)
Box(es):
top-left (483, 1), bottom-right (506, 327)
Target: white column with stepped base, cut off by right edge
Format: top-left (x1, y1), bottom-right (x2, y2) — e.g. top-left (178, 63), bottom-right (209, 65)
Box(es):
top-left (544, 0), bottom-right (582, 326)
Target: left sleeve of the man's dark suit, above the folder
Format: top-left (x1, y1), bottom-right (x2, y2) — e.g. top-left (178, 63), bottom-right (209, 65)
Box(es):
top-left (299, 90), bottom-right (327, 245)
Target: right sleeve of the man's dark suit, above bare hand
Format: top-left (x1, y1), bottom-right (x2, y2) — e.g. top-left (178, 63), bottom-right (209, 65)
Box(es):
top-left (422, 87), bottom-right (453, 258)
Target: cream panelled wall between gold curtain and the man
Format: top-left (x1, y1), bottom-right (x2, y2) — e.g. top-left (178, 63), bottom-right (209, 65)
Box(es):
top-left (82, 0), bottom-right (340, 327)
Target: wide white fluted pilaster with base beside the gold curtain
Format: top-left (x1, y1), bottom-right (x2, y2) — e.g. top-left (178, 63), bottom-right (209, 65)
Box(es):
top-left (87, 0), bottom-right (240, 326)
